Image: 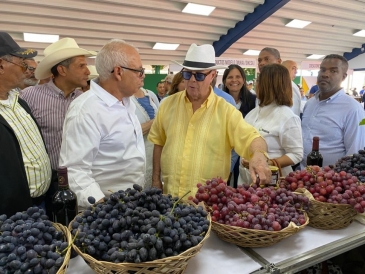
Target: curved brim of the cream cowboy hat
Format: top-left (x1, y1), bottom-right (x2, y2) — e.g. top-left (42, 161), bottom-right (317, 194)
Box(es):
top-left (34, 48), bottom-right (95, 80)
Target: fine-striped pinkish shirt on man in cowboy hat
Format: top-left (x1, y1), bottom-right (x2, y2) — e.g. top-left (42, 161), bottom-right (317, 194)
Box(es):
top-left (20, 81), bottom-right (82, 170)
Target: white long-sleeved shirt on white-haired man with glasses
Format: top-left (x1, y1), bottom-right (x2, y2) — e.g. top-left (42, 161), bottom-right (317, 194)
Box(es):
top-left (60, 81), bottom-right (146, 207)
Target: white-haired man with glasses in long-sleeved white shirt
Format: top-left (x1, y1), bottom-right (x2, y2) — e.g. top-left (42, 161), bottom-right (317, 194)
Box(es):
top-left (60, 39), bottom-right (145, 207)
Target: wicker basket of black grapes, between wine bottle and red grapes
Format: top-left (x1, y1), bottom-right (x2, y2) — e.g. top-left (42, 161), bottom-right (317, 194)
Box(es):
top-left (69, 203), bottom-right (212, 274)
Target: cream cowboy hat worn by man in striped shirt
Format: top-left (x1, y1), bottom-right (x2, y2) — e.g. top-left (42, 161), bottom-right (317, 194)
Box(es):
top-left (35, 38), bottom-right (96, 80)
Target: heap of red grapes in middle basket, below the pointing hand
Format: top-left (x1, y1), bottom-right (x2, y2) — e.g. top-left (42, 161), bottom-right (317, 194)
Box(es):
top-left (189, 178), bottom-right (309, 231)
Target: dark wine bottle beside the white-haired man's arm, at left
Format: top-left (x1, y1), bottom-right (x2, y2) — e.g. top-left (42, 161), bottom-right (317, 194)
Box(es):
top-left (52, 166), bottom-right (78, 226)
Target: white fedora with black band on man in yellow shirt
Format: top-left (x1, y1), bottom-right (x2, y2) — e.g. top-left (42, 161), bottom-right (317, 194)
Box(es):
top-left (172, 44), bottom-right (227, 70)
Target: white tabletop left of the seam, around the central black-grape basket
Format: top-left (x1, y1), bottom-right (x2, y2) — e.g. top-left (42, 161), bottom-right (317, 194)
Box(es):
top-left (66, 231), bottom-right (261, 274)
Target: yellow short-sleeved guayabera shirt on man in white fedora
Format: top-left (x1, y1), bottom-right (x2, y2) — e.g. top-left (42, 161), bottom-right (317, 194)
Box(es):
top-left (148, 89), bottom-right (261, 197)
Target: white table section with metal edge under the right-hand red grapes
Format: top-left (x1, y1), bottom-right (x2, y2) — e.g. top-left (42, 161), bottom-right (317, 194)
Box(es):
top-left (243, 221), bottom-right (365, 273)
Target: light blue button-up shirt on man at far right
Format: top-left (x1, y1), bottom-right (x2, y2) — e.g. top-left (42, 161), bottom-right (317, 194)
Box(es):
top-left (301, 89), bottom-right (365, 169)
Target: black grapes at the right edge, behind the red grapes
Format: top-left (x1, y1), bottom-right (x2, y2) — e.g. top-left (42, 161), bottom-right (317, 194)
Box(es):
top-left (334, 149), bottom-right (365, 183)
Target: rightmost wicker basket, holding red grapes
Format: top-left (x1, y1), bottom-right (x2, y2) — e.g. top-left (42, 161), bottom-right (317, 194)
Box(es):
top-left (296, 189), bottom-right (357, 230)
